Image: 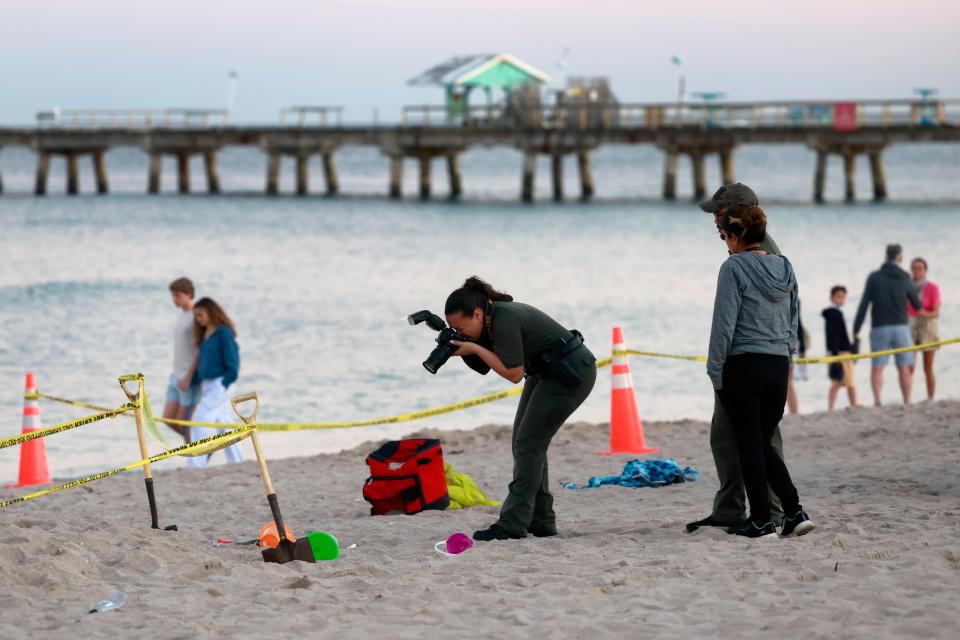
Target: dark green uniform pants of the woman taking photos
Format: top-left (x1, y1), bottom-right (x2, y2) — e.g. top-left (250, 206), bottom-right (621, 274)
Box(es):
top-left (497, 347), bottom-right (597, 536)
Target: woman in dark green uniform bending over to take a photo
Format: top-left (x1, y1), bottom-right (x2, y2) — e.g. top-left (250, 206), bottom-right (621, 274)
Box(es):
top-left (444, 276), bottom-right (597, 541)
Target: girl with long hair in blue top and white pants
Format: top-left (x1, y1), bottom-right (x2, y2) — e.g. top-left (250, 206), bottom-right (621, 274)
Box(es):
top-left (187, 298), bottom-right (243, 467)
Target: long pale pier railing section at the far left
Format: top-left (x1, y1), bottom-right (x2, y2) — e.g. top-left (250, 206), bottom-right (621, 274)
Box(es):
top-left (37, 109), bottom-right (230, 129)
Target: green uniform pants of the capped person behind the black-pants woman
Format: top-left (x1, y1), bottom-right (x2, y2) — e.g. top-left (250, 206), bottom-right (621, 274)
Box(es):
top-left (710, 393), bottom-right (783, 526)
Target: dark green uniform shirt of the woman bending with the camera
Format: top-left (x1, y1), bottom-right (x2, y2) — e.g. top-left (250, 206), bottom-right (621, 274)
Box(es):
top-left (492, 302), bottom-right (571, 372)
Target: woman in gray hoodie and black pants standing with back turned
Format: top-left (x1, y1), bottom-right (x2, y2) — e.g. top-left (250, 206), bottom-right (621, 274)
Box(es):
top-left (707, 207), bottom-right (814, 538)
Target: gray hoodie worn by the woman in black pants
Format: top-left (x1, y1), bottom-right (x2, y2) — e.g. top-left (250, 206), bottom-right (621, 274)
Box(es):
top-left (707, 251), bottom-right (799, 389)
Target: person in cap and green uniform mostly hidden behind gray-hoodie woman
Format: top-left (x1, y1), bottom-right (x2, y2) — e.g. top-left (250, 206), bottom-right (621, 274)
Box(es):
top-left (687, 182), bottom-right (783, 533)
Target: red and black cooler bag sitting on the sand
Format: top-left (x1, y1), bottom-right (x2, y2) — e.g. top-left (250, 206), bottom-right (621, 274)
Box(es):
top-left (363, 439), bottom-right (450, 516)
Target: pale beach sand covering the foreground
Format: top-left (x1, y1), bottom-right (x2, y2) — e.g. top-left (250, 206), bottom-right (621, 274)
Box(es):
top-left (0, 402), bottom-right (960, 639)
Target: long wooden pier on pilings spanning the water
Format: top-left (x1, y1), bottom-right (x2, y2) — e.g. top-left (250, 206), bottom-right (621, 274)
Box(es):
top-left (0, 100), bottom-right (960, 202)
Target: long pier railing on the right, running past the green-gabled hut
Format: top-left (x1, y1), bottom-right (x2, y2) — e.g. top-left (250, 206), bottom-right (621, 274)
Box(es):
top-left (401, 100), bottom-right (960, 130)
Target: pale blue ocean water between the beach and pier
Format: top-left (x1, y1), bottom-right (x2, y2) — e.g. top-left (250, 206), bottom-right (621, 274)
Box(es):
top-left (0, 145), bottom-right (960, 480)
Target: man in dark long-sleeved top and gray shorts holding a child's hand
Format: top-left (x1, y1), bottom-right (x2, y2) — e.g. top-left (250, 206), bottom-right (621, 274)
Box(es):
top-left (853, 244), bottom-right (923, 407)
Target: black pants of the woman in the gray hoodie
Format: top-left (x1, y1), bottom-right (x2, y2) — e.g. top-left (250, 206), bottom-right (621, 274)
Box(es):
top-left (719, 353), bottom-right (800, 525)
